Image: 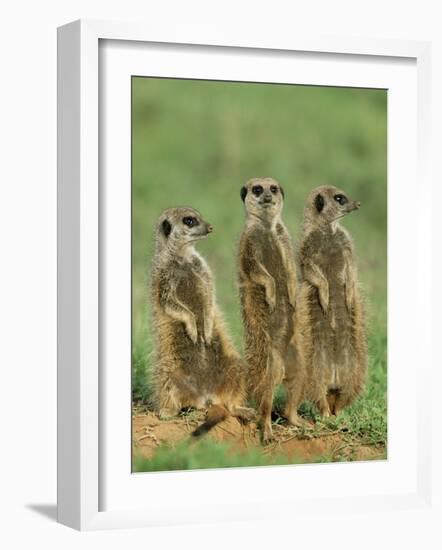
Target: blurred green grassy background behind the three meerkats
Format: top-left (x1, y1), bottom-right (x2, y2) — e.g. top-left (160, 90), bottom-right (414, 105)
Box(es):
top-left (132, 77), bottom-right (387, 418)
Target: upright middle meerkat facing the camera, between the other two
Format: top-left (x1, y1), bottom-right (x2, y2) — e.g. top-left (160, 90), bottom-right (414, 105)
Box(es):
top-left (238, 178), bottom-right (303, 444)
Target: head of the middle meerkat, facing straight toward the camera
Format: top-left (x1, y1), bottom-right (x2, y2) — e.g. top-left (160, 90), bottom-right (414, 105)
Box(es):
top-left (241, 178), bottom-right (284, 220)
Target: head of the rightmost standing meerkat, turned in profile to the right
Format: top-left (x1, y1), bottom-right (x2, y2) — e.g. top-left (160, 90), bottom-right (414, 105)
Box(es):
top-left (305, 185), bottom-right (361, 229)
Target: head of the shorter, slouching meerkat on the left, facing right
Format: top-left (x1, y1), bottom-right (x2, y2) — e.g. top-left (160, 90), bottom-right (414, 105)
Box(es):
top-left (157, 207), bottom-right (213, 252)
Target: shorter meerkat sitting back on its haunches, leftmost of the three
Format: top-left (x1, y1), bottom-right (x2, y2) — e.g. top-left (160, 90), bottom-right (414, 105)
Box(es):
top-left (151, 208), bottom-right (253, 435)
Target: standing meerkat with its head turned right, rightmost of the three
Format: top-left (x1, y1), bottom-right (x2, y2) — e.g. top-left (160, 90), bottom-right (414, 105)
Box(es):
top-left (296, 186), bottom-right (367, 416)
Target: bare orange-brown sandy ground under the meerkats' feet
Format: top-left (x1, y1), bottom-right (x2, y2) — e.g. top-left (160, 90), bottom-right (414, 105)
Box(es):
top-left (133, 412), bottom-right (385, 468)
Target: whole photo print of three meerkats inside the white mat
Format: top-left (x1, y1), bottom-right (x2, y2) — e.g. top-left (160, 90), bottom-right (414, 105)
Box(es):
top-left (131, 77), bottom-right (387, 472)
